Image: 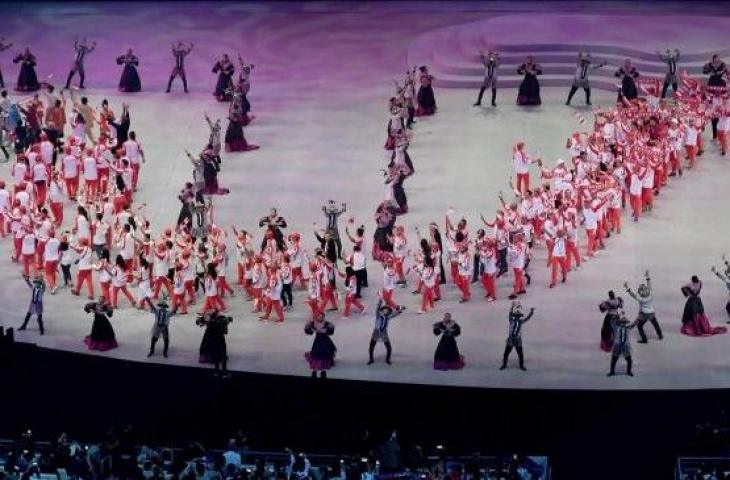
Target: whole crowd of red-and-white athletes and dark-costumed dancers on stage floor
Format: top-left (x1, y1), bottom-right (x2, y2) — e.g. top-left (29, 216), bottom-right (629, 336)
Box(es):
top-left (0, 40), bottom-right (730, 376)
